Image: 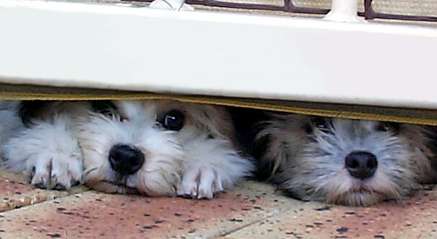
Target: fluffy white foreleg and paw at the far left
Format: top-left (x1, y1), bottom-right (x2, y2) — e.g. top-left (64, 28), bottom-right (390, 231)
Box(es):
top-left (3, 115), bottom-right (83, 189)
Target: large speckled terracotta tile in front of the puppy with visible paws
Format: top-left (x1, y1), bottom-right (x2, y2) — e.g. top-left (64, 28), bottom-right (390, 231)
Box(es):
top-left (0, 183), bottom-right (290, 238)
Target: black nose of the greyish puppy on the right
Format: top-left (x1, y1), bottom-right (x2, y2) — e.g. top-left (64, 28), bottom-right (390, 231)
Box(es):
top-left (345, 151), bottom-right (378, 179)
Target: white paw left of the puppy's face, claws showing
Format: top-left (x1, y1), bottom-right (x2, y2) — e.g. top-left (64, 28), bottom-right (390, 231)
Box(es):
top-left (28, 152), bottom-right (82, 190)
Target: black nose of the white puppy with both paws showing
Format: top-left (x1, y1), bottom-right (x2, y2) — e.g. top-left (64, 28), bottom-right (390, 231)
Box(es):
top-left (109, 144), bottom-right (144, 175)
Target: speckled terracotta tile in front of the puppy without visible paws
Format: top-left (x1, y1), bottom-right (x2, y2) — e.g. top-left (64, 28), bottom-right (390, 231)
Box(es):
top-left (227, 188), bottom-right (437, 239)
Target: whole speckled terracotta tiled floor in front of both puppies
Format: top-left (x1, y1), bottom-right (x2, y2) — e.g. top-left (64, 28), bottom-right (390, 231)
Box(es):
top-left (0, 169), bottom-right (437, 239)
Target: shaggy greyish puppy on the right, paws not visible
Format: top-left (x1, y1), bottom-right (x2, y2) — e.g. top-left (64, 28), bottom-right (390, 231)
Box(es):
top-left (257, 114), bottom-right (436, 206)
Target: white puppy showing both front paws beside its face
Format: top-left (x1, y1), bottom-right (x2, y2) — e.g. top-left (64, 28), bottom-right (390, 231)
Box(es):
top-left (3, 100), bottom-right (253, 198)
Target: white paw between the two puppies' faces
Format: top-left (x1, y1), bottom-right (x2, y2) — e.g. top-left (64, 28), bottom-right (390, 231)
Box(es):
top-left (177, 167), bottom-right (223, 199)
